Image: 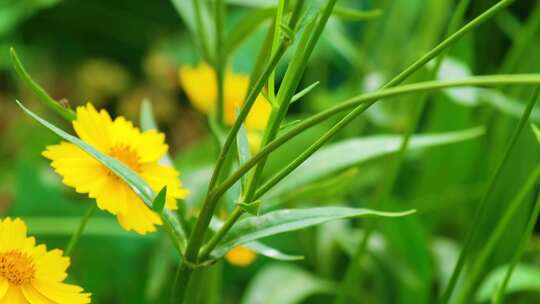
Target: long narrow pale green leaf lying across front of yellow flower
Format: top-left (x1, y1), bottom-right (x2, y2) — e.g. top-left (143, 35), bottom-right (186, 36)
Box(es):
top-left (16, 100), bottom-right (187, 250)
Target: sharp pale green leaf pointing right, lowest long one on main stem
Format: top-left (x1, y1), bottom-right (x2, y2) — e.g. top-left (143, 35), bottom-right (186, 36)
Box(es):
top-left (212, 207), bottom-right (415, 258)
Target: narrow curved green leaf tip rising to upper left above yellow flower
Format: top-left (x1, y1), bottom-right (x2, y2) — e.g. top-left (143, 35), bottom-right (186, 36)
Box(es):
top-left (10, 48), bottom-right (75, 120)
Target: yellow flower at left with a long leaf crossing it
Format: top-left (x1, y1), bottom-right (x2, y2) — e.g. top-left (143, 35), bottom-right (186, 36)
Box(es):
top-left (43, 104), bottom-right (188, 234)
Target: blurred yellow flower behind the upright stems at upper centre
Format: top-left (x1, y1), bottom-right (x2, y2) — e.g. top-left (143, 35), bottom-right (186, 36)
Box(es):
top-left (178, 63), bottom-right (272, 150)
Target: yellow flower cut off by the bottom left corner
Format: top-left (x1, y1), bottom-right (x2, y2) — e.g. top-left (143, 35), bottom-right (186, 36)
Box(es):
top-left (0, 218), bottom-right (90, 304)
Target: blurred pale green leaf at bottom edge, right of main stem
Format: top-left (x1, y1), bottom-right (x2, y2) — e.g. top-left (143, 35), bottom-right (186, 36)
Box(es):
top-left (241, 264), bottom-right (336, 304)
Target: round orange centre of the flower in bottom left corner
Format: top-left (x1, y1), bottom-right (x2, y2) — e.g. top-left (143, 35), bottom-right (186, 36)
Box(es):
top-left (0, 250), bottom-right (36, 285)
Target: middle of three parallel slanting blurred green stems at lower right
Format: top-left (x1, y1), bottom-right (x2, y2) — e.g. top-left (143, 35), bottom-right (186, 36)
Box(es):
top-left (456, 165), bottom-right (540, 303)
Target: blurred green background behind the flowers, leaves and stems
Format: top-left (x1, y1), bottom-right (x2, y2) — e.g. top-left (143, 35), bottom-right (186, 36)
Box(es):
top-left (0, 0), bottom-right (540, 304)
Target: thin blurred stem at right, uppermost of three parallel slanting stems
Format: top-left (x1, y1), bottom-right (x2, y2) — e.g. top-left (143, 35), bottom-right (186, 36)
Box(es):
top-left (441, 88), bottom-right (539, 303)
